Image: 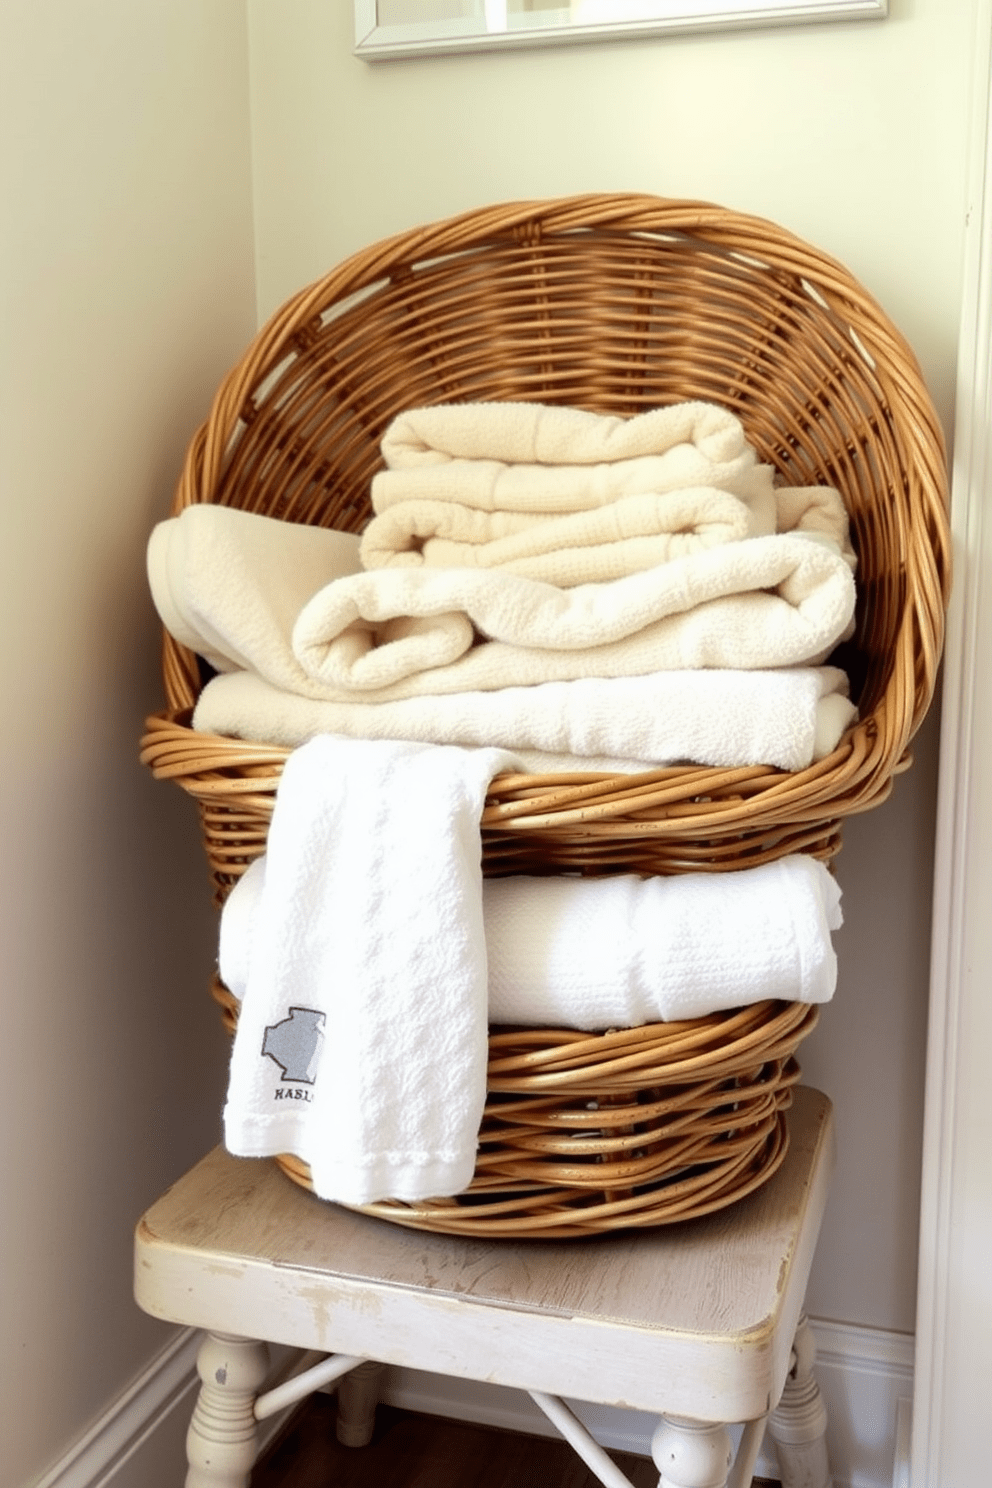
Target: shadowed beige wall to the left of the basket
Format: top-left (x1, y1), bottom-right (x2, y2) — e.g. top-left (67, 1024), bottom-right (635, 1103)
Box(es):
top-left (0, 0), bottom-right (254, 1488)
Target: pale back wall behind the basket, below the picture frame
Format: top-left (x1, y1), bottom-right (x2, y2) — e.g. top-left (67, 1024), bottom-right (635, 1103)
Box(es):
top-left (248, 0), bottom-right (974, 1330)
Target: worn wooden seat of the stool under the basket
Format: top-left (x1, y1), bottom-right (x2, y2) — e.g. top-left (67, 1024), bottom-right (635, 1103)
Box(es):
top-left (135, 1086), bottom-right (833, 1482)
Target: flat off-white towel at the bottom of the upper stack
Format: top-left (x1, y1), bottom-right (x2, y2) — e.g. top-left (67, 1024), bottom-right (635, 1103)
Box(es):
top-left (193, 667), bottom-right (857, 774)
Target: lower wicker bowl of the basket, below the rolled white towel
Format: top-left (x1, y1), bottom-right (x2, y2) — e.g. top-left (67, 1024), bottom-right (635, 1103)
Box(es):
top-left (214, 982), bottom-right (819, 1240)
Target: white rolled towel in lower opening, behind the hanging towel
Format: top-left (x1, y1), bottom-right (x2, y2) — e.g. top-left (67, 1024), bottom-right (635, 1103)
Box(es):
top-left (220, 854), bottom-right (842, 1030)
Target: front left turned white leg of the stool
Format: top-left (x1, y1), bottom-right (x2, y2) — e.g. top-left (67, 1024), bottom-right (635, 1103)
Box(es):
top-left (186, 1333), bottom-right (269, 1488)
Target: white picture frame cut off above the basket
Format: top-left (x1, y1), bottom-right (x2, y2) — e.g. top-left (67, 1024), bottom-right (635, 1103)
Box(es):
top-left (354, 0), bottom-right (888, 62)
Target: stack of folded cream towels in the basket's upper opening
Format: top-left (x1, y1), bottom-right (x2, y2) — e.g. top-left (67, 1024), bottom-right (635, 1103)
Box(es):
top-left (149, 403), bottom-right (855, 772)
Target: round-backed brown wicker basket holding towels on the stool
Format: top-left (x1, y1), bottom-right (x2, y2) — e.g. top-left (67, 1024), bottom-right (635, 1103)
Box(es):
top-left (143, 195), bottom-right (949, 1235)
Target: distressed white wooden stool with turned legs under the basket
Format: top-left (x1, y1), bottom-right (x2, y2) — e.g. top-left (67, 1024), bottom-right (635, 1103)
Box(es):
top-left (135, 1088), bottom-right (833, 1488)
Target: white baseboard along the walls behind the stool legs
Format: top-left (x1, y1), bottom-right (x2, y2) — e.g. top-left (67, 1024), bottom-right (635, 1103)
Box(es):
top-left (30, 1318), bottom-right (913, 1488)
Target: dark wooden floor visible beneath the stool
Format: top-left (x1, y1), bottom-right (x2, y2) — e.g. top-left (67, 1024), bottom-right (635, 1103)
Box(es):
top-left (251, 1394), bottom-right (770, 1488)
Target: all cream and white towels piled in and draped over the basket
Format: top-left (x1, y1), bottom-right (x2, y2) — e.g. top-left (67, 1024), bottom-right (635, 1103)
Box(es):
top-left (149, 403), bottom-right (855, 1204)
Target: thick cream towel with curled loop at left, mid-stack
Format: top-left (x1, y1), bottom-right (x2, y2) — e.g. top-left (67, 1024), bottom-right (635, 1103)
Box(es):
top-left (293, 533), bottom-right (855, 702)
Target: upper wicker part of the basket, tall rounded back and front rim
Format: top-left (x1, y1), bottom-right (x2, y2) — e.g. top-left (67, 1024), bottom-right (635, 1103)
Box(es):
top-left (143, 195), bottom-right (949, 897)
